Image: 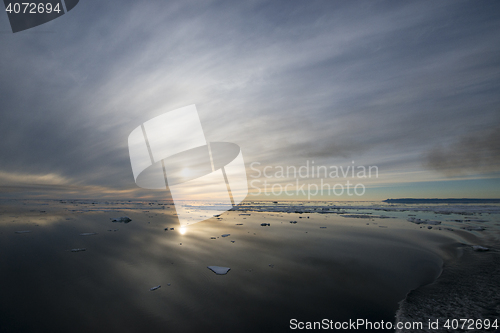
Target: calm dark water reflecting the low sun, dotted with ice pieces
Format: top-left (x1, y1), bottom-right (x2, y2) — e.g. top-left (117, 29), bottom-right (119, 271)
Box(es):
top-left (0, 201), bottom-right (498, 332)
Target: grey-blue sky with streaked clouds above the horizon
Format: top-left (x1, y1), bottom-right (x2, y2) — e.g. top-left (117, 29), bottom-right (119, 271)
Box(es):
top-left (0, 0), bottom-right (500, 200)
